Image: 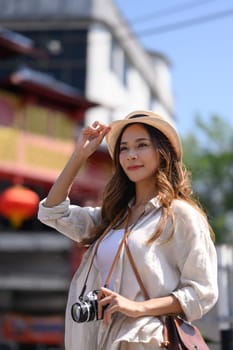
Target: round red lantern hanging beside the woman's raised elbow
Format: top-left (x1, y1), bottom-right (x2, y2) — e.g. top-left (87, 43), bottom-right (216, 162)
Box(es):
top-left (0, 185), bottom-right (39, 228)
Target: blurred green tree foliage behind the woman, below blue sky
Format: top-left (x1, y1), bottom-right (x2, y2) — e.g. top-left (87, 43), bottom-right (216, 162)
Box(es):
top-left (182, 115), bottom-right (233, 243)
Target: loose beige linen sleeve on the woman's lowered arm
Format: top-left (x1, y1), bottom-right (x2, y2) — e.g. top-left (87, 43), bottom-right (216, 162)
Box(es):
top-left (173, 201), bottom-right (218, 321)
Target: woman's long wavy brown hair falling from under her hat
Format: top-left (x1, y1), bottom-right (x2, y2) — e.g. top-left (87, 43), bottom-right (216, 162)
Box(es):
top-left (82, 122), bottom-right (214, 246)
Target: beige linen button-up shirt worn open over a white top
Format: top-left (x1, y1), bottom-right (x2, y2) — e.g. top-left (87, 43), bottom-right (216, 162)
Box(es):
top-left (38, 197), bottom-right (218, 350)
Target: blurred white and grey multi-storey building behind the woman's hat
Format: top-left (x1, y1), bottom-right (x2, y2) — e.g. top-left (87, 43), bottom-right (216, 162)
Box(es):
top-left (0, 0), bottom-right (174, 122)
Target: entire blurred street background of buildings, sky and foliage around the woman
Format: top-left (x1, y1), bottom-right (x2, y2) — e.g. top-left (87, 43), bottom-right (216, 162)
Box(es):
top-left (0, 0), bottom-right (233, 350)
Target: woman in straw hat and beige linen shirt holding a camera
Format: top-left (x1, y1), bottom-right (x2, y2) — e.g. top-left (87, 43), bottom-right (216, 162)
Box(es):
top-left (38, 111), bottom-right (218, 350)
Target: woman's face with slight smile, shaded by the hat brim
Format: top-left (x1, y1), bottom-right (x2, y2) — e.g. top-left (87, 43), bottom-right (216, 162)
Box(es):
top-left (119, 124), bottom-right (159, 183)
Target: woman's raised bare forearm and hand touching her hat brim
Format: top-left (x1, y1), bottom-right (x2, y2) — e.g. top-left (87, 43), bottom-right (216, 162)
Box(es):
top-left (44, 122), bottom-right (110, 207)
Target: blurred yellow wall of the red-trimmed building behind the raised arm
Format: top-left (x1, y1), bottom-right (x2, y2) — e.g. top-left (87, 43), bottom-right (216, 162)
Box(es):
top-left (0, 91), bottom-right (75, 177)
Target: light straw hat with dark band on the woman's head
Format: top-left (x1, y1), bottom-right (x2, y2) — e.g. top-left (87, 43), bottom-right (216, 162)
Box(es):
top-left (106, 110), bottom-right (182, 160)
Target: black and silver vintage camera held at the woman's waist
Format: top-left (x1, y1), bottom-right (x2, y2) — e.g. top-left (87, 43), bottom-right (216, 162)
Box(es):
top-left (71, 290), bottom-right (103, 323)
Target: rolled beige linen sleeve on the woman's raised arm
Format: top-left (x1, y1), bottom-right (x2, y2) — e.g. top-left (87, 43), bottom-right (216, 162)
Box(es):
top-left (38, 198), bottom-right (100, 242)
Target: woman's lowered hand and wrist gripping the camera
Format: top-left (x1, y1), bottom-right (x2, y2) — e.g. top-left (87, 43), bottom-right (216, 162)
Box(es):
top-left (98, 287), bottom-right (140, 325)
